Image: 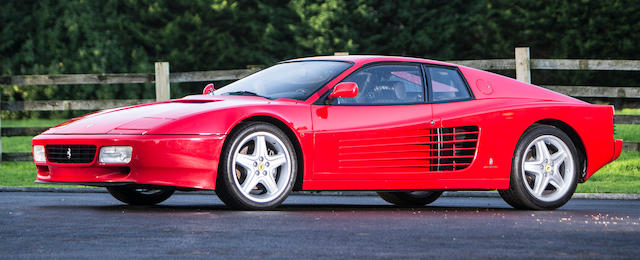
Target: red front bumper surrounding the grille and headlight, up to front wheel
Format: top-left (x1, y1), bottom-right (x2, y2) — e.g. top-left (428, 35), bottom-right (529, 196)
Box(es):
top-left (33, 135), bottom-right (225, 189)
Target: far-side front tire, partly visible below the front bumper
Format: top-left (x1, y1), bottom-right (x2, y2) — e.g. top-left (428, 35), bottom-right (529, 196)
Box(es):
top-left (107, 186), bottom-right (175, 205)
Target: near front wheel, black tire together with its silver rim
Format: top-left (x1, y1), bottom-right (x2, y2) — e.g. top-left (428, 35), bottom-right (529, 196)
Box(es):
top-left (216, 122), bottom-right (298, 210)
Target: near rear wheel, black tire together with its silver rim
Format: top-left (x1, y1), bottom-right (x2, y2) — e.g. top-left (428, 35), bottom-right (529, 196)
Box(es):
top-left (498, 125), bottom-right (581, 210)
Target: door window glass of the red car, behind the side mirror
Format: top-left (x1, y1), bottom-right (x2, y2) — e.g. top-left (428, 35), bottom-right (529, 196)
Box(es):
top-left (332, 65), bottom-right (425, 106)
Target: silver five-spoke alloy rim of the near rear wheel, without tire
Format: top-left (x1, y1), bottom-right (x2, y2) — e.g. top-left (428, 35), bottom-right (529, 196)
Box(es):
top-left (521, 135), bottom-right (575, 202)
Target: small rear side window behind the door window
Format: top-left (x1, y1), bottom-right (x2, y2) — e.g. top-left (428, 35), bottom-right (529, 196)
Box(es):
top-left (425, 66), bottom-right (471, 102)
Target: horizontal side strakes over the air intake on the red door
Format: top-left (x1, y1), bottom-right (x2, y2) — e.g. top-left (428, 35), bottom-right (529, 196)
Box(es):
top-left (338, 126), bottom-right (479, 172)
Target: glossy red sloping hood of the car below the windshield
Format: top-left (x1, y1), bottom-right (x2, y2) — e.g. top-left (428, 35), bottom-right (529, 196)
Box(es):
top-left (43, 95), bottom-right (284, 135)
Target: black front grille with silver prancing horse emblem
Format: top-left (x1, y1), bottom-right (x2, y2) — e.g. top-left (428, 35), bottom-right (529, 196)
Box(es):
top-left (46, 144), bottom-right (96, 163)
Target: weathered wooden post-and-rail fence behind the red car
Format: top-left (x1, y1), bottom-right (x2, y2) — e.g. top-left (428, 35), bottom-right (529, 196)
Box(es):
top-left (0, 48), bottom-right (640, 162)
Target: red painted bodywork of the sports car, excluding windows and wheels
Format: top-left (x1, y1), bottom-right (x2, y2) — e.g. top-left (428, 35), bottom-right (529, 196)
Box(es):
top-left (33, 56), bottom-right (622, 190)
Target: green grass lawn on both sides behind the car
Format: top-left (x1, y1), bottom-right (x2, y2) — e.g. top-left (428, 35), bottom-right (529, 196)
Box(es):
top-left (0, 109), bottom-right (640, 194)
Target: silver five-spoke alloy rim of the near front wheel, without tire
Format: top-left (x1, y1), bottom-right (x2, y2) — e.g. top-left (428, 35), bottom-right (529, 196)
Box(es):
top-left (232, 132), bottom-right (292, 203)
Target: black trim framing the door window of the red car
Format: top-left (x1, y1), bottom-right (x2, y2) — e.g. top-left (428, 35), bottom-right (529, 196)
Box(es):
top-left (314, 61), bottom-right (430, 107)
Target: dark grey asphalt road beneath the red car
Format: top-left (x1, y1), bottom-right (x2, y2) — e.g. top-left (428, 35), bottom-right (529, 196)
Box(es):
top-left (0, 192), bottom-right (640, 259)
